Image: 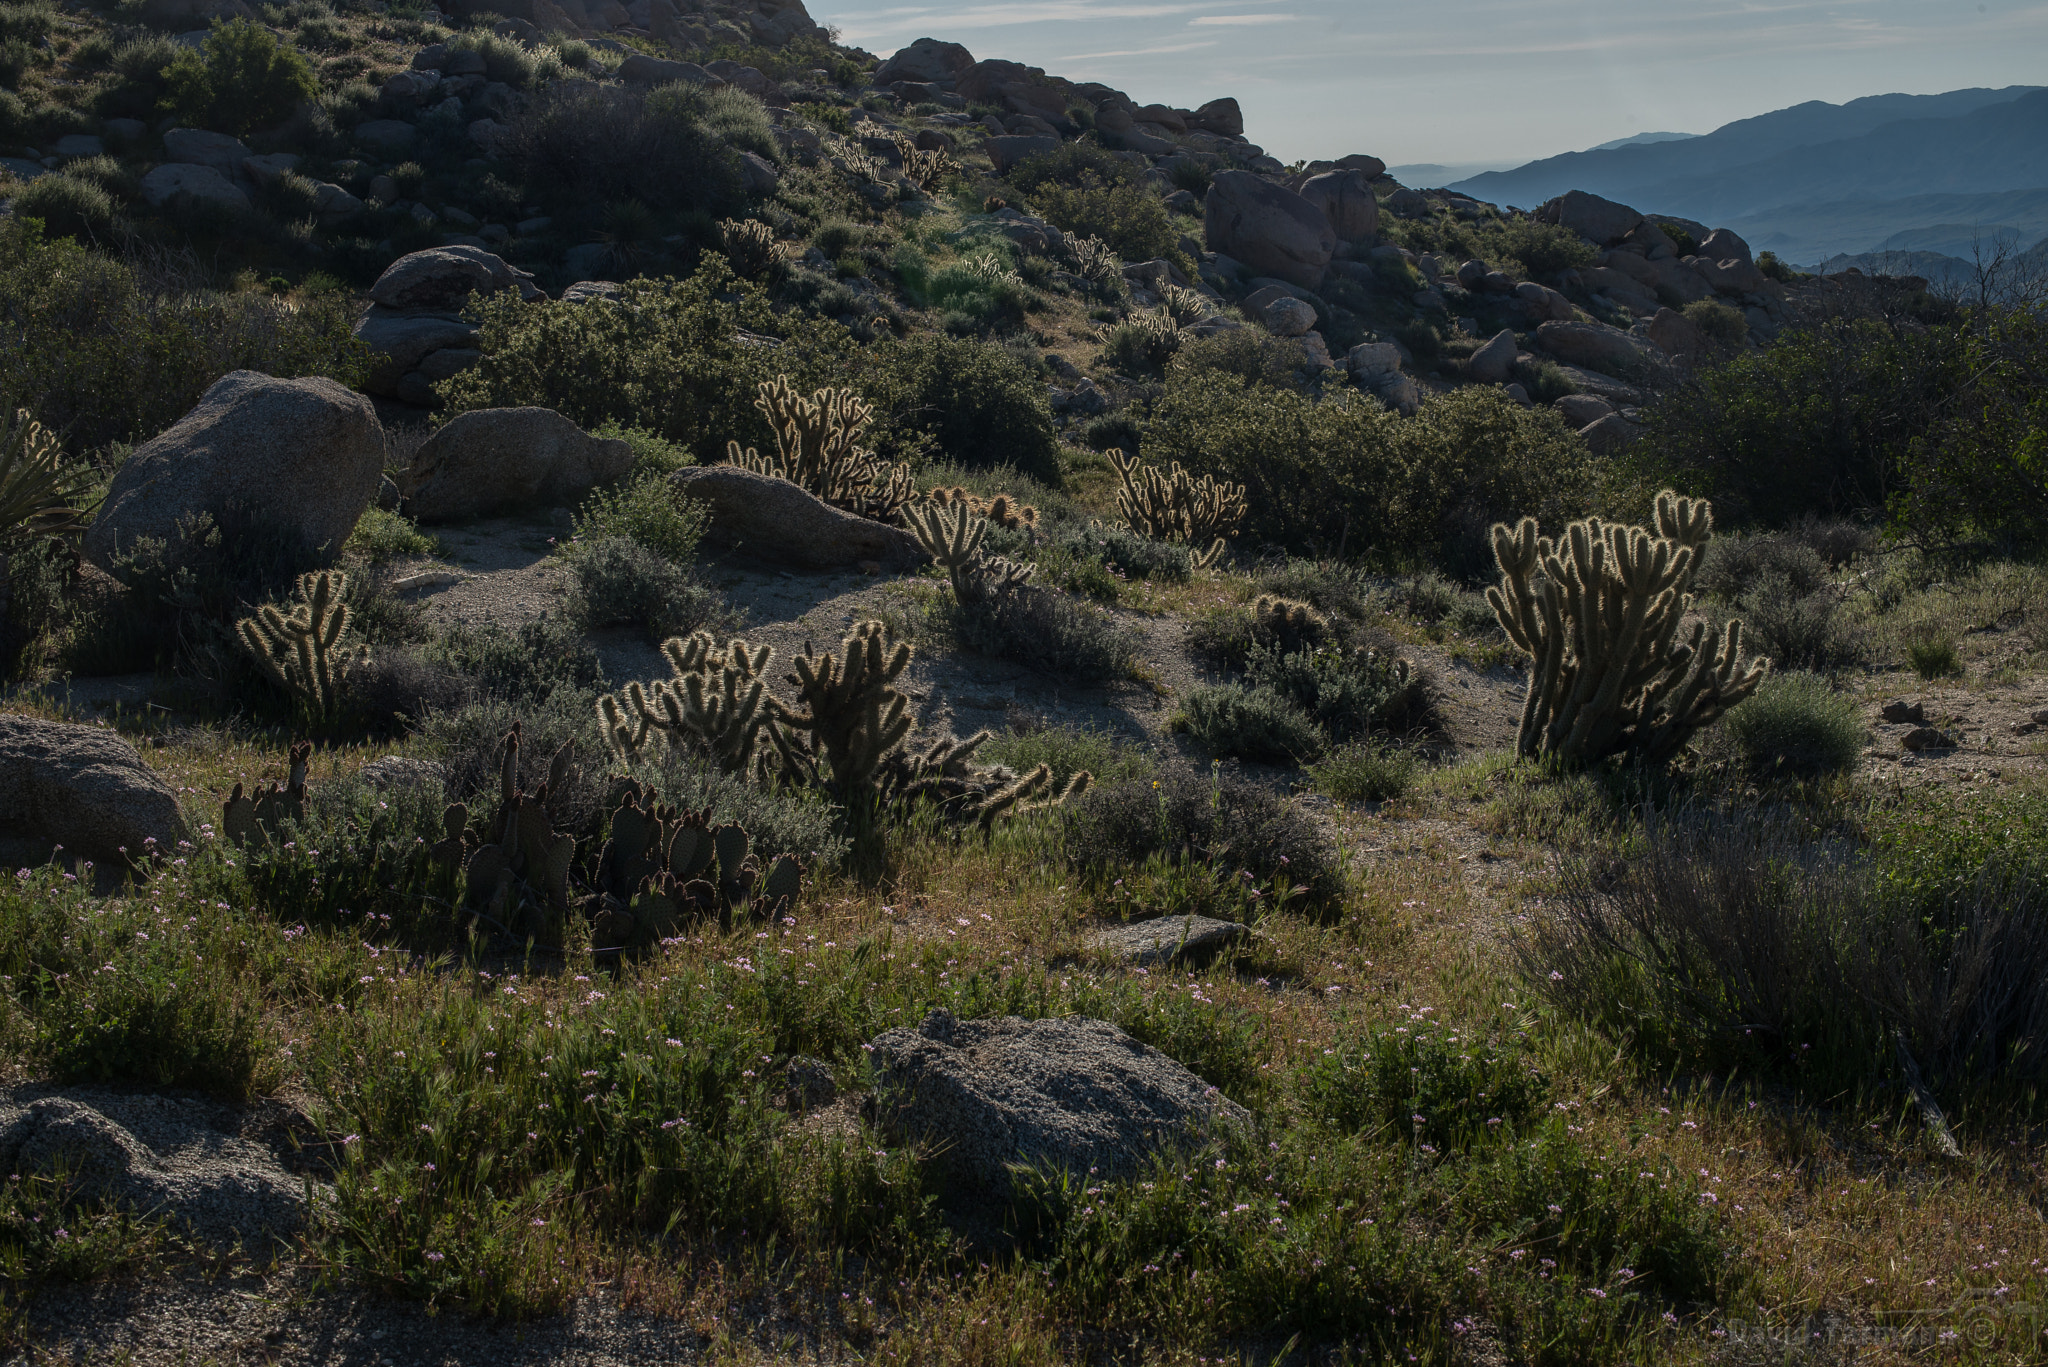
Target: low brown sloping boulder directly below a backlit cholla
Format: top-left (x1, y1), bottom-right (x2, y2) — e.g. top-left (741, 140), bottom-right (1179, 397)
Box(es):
top-left (670, 465), bottom-right (926, 570)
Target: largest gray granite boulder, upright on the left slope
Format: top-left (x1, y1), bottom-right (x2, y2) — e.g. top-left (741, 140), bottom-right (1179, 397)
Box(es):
top-left (84, 371), bottom-right (385, 570)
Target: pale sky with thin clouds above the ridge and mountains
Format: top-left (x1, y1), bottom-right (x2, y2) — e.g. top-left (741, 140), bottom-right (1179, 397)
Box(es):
top-left (809, 0), bottom-right (2048, 166)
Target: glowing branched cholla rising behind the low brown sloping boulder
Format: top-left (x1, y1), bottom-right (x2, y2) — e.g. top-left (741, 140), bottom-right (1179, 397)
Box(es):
top-left (725, 375), bottom-right (918, 521)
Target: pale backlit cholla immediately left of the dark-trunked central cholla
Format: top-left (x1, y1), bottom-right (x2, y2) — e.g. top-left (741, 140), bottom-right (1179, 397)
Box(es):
top-left (598, 631), bottom-right (774, 773)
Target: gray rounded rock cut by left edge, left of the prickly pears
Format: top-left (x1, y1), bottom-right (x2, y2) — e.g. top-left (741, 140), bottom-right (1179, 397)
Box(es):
top-left (0, 715), bottom-right (186, 863)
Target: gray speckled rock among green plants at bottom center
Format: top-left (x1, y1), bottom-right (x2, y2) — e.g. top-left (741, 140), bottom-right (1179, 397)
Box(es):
top-left (870, 1010), bottom-right (1251, 1199)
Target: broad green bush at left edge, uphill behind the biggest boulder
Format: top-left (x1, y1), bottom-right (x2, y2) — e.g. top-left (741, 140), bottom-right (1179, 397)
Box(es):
top-left (0, 217), bottom-right (369, 449)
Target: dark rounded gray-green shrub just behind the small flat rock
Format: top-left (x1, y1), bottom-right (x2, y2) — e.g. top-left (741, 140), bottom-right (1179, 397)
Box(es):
top-left (1067, 762), bottom-right (1341, 898)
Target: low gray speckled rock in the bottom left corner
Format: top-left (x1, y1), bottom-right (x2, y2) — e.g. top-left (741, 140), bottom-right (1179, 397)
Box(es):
top-left (0, 1088), bottom-right (305, 1252)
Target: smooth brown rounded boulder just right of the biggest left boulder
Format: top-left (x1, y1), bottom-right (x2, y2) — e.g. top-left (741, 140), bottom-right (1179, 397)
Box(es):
top-left (406, 408), bottom-right (633, 523)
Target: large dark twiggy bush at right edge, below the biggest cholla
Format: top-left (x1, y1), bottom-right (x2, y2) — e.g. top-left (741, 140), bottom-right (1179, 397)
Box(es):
top-left (1520, 810), bottom-right (2048, 1088)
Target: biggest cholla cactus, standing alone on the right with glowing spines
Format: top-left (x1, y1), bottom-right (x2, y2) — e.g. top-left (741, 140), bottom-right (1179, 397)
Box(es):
top-left (1487, 492), bottom-right (1767, 762)
